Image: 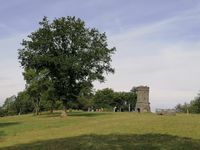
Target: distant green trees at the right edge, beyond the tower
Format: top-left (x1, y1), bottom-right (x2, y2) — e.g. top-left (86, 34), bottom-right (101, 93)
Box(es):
top-left (175, 94), bottom-right (200, 114)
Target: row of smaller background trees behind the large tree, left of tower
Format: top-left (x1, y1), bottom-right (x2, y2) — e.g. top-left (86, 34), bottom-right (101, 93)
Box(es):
top-left (0, 88), bottom-right (136, 117)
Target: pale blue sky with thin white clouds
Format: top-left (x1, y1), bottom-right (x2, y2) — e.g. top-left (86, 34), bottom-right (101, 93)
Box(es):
top-left (0, 0), bottom-right (200, 110)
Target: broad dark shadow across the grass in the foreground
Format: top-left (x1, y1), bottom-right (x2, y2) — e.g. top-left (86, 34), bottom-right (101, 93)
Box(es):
top-left (1, 134), bottom-right (200, 150)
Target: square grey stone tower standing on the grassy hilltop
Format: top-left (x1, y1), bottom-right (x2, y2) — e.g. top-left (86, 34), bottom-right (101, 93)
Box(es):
top-left (135, 86), bottom-right (151, 112)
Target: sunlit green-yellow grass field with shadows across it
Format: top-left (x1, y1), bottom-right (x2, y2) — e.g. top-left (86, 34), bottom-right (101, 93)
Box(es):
top-left (0, 112), bottom-right (200, 150)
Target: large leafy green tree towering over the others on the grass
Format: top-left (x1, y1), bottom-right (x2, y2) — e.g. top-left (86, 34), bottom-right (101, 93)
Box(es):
top-left (19, 17), bottom-right (115, 114)
